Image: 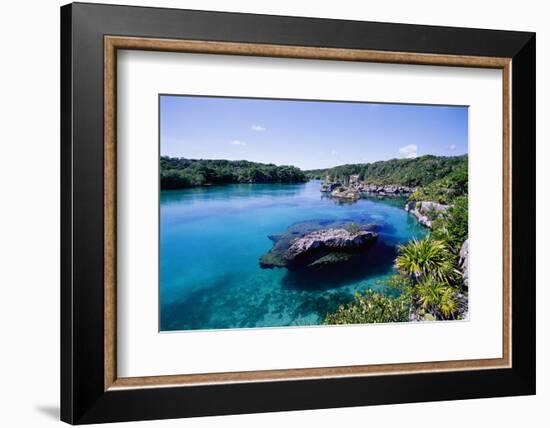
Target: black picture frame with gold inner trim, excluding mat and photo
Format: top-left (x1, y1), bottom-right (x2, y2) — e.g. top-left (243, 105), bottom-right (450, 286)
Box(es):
top-left (61, 3), bottom-right (536, 424)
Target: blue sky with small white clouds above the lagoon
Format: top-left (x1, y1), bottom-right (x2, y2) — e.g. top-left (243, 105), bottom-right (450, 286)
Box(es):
top-left (160, 95), bottom-right (468, 169)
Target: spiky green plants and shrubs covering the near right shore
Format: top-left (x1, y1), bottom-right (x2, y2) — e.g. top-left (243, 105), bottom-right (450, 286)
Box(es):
top-left (325, 156), bottom-right (468, 324)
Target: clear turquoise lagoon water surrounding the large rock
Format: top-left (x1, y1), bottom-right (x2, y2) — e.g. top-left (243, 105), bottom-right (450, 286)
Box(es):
top-left (160, 181), bottom-right (426, 331)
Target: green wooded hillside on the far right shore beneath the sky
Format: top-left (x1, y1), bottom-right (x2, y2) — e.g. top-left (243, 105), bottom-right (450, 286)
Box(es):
top-left (306, 155), bottom-right (468, 187)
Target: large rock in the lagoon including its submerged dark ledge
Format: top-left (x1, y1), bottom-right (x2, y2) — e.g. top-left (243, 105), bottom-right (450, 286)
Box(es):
top-left (259, 220), bottom-right (377, 268)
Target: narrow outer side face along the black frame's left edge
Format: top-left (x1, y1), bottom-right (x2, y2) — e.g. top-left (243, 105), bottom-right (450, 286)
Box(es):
top-left (60, 4), bottom-right (75, 424)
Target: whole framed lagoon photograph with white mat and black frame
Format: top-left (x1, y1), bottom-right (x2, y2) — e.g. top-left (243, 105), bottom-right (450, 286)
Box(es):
top-left (61, 3), bottom-right (535, 424)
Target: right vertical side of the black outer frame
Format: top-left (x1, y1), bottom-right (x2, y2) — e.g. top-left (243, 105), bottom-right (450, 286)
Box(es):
top-left (511, 33), bottom-right (536, 395)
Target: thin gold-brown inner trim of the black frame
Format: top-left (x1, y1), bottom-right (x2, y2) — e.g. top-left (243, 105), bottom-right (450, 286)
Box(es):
top-left (104, 36), bottom-right (512, 391)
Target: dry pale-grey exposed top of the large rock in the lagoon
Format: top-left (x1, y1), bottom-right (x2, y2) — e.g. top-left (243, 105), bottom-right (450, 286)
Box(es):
top-left (283, 229), bottom-right (377, 262)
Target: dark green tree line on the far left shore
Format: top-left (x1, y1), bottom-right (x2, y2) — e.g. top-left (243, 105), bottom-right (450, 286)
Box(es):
top-left (160, 156), bottom-right (307, 189)
